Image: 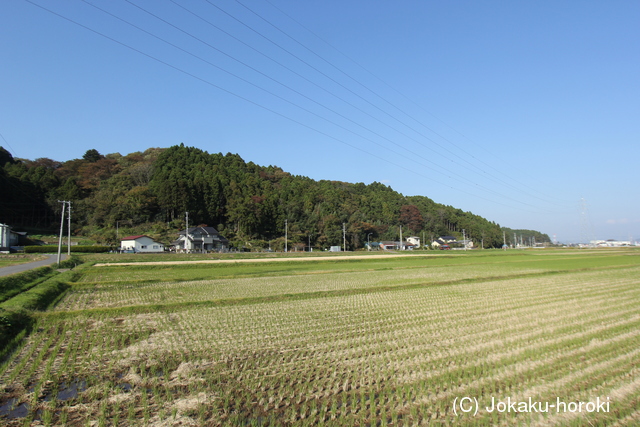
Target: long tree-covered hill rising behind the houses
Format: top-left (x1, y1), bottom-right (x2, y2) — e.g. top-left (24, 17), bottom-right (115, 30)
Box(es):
top-left (0, 144), bottom-right (549, 249)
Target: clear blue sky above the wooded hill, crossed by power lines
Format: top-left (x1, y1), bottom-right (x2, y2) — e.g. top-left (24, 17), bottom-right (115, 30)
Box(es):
top-left (0, 0), bottom-right (640, 242)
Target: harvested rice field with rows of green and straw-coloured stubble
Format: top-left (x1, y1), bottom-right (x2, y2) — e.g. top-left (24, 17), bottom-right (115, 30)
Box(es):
top-left (0, 249), bottom-right (640, 426)
